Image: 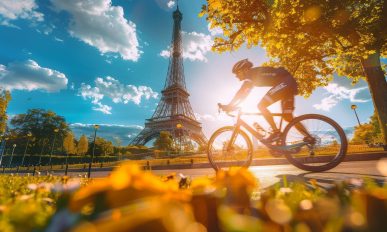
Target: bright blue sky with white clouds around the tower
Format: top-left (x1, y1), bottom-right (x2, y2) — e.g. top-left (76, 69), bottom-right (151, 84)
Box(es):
top-left (0, 0), bottom-right (373, 144)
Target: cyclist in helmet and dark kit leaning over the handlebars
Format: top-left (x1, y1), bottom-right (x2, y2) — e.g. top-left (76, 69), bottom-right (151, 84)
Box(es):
top-left (221, 59), bottom-right (308, 144)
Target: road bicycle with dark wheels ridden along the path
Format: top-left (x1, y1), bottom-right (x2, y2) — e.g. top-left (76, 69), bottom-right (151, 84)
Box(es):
top-left (207, 104), bottom-right (348, 172)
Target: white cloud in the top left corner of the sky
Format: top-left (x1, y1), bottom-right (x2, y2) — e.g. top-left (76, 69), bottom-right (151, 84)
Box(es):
top-left (0, 0), bottom-right (44, 27)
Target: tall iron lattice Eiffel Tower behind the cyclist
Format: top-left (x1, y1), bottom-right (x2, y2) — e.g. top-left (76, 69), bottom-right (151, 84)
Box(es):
top-left (130, 5), bottom-right (207, 145)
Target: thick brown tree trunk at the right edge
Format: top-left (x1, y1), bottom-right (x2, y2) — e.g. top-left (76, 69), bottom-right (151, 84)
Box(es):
top-left (362, 52), bottom-right (387, 148)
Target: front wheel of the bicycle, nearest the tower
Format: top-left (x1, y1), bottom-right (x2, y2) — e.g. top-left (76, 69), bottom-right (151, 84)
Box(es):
top-left (207, 126), bottom-right (253, 171)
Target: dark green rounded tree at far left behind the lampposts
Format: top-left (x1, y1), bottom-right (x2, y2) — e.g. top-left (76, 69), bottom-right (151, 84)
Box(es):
top-left (11, 109), bottom-right (70, 154)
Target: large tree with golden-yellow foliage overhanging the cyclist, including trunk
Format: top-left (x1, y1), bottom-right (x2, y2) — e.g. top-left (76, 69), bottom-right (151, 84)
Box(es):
top-left (200, 0), bottom-right (387, 144)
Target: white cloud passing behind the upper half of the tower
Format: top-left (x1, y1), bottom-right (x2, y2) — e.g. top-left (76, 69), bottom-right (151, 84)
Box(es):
top-left (159, 31), bottom-right (213, 62)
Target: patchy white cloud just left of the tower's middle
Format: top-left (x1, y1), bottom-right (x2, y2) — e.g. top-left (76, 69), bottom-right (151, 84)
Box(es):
top-left (78, 76), bottom-right (158, 114)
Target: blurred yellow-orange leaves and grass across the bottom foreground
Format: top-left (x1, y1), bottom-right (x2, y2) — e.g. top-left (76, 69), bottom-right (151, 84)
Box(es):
top-left (0, 163), bottom-right (387, 232)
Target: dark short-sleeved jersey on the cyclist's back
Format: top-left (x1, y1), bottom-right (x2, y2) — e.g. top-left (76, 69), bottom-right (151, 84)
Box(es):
top-left (245, 67), bottom-right (297, 87)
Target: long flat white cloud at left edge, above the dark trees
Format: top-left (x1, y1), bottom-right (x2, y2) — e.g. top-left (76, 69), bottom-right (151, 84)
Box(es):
top-left (0, 60), bottom-right (68, 92)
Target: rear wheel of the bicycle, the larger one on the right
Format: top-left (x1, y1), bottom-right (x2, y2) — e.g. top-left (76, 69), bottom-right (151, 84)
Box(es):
top-left (282, 114), bottom-right (348, 172)
